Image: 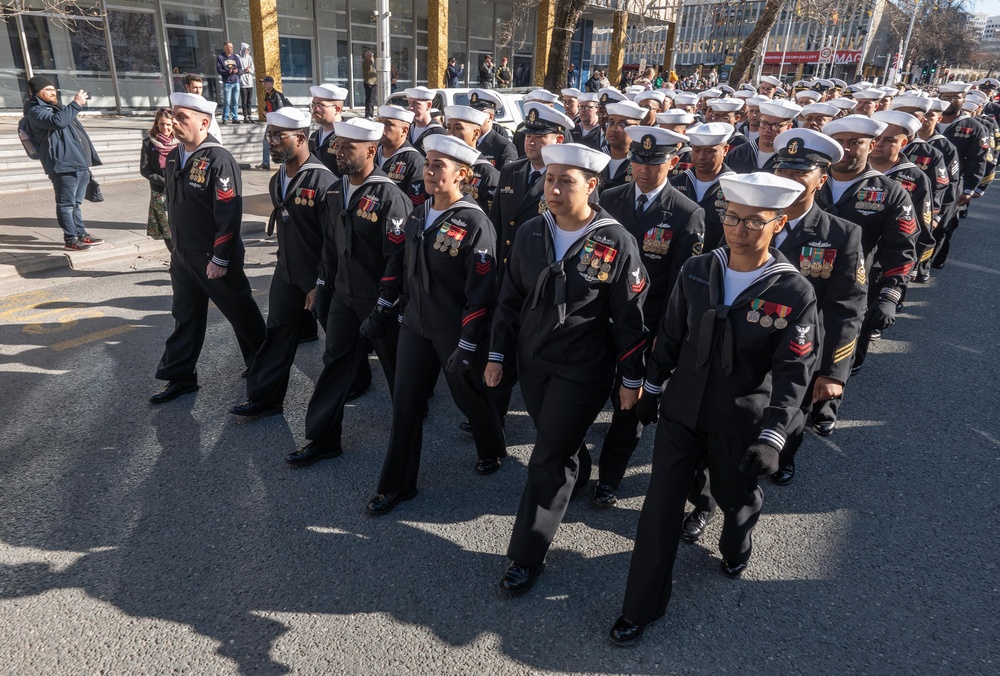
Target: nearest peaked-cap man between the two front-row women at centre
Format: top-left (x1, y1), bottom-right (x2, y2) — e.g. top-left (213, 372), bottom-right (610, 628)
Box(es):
top-left (482, 103), bottom-right (573, 428)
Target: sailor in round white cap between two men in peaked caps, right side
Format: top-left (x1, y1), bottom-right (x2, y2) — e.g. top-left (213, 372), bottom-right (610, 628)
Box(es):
top-left (670, 122), bottom-right (735, 253)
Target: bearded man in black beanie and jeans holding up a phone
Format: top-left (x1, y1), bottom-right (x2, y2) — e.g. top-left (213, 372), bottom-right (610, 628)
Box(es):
top-left (24, 75), bottom-right (104, 251)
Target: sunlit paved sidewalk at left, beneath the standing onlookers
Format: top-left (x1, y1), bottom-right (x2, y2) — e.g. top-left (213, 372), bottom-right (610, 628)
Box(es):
top-left (0, 169), bottom-right (271, 284)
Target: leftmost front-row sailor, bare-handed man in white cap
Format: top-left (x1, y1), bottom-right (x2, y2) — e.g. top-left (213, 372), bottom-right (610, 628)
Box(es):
top-left (150, 92), bottom-right (264, 404)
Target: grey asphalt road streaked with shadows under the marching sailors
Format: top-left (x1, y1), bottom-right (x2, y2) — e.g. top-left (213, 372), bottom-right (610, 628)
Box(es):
top-left (0, 194), bottom-right (1000, 674)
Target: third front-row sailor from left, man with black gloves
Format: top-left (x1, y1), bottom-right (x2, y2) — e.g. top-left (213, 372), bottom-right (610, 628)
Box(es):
top-left (286, 118), bottom-right (413, 466)
